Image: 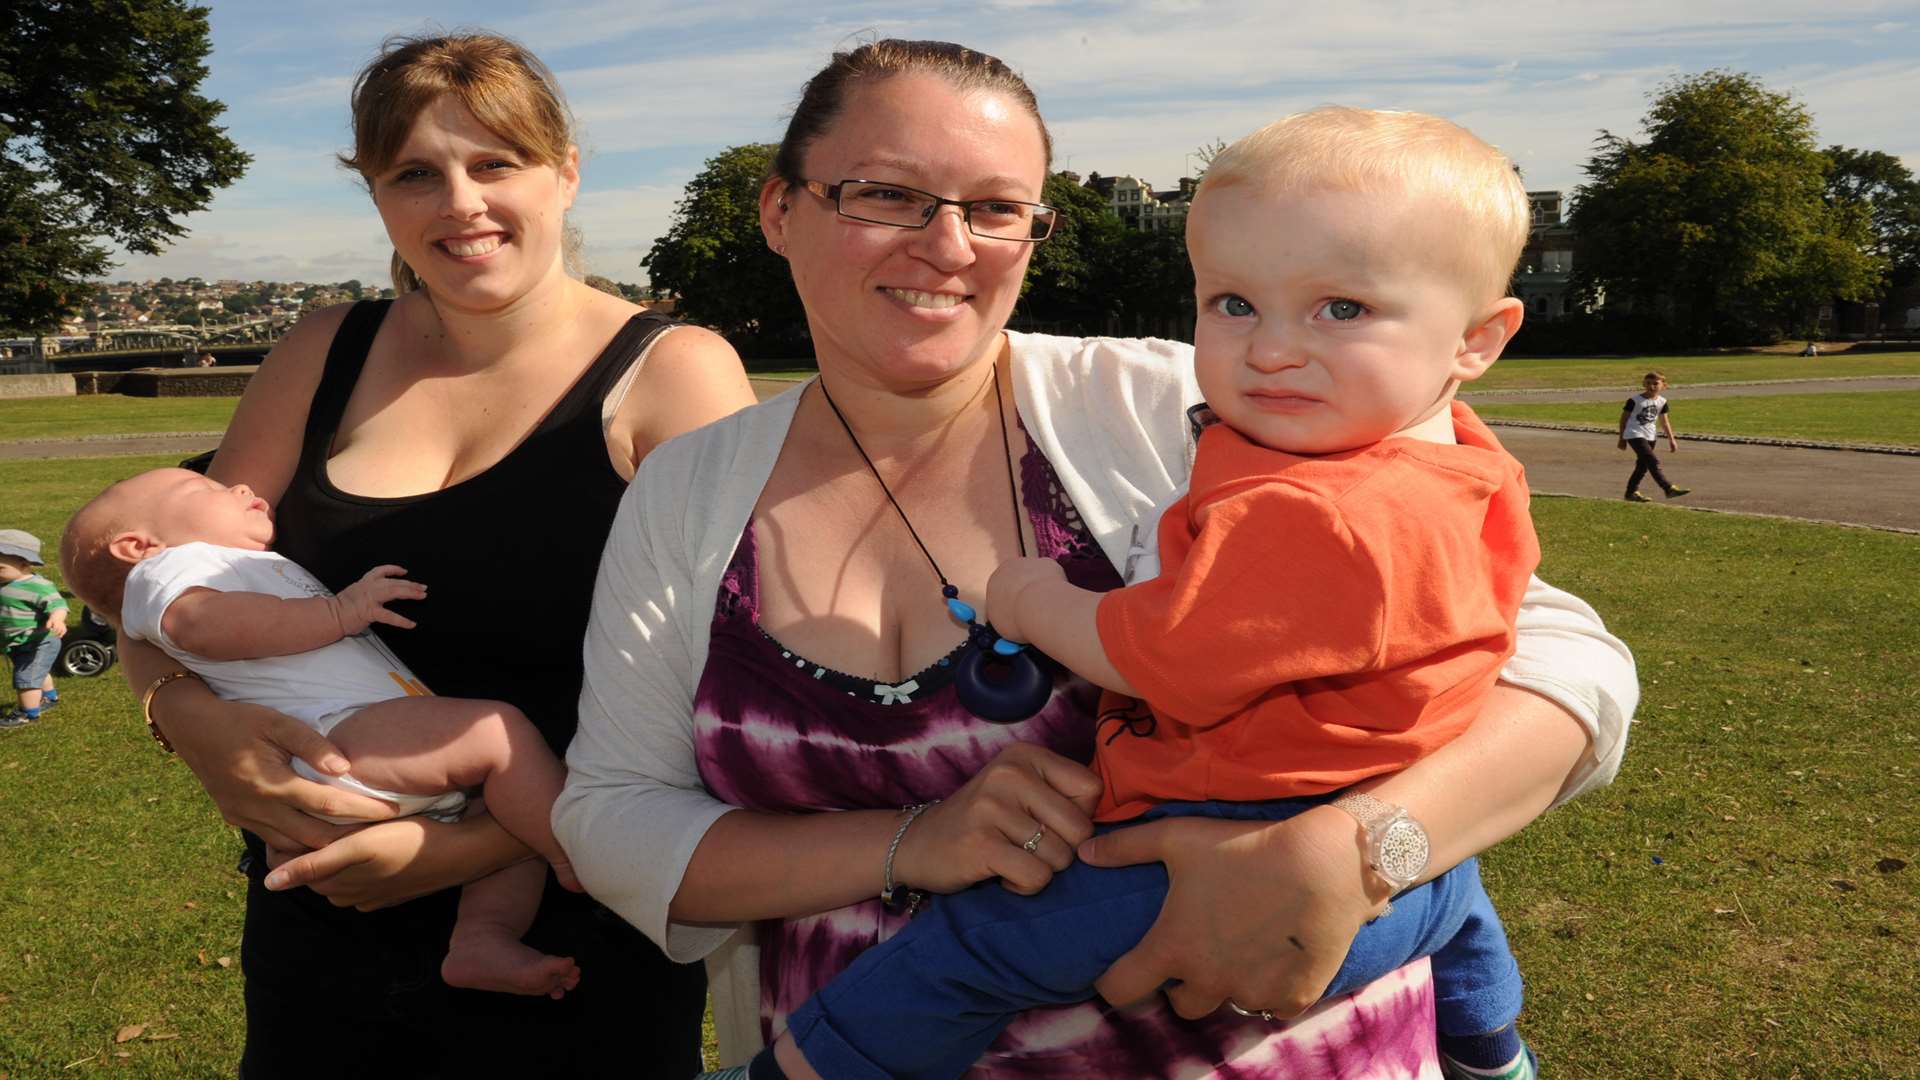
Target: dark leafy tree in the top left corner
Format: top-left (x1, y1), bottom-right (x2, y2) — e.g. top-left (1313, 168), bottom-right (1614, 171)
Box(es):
top-left (0, 0), bottom-right (250, 331)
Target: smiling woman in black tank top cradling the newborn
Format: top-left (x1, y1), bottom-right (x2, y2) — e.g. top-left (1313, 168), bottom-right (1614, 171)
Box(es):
top-left (112, 35), bottom-right (751, 1080)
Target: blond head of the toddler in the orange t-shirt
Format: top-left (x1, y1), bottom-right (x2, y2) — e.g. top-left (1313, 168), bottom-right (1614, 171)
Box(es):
top-left (1187, 108), bottom-right (1528, 454)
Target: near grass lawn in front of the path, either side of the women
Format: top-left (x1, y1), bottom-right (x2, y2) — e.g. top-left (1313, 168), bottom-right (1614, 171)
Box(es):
top-left (0, 457), bottom-right (1920, 1080)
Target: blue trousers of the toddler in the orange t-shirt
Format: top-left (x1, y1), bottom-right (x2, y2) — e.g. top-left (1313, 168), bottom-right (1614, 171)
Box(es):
top-left (787, 796), bottom-right (1521, 1080)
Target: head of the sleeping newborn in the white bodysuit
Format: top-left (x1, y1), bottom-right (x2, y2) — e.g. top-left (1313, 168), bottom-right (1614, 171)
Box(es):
top-left (60, 469), bottom-right (273, 619)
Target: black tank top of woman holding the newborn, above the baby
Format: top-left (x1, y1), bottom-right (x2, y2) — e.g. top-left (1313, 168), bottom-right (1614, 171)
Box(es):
top-left (275, 300), bottom-right (670, 753)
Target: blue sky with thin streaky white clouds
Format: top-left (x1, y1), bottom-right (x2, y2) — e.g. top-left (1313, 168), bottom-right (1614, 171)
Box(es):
top-left (113, 0), bottom-right (1920, 282)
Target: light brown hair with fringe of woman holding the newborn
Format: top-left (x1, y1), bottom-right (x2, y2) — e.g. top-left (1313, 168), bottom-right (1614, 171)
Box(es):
top-left (340, 33), bottom-right (580, 294)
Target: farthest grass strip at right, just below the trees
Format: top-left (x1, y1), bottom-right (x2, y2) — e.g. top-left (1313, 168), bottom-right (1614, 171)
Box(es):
top-left (1469, 352), bottom-right (1920, 396)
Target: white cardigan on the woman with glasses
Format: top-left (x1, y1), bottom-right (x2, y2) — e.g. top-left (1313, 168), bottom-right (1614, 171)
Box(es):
top-left (553, 332), bottom-right (1640, 1045)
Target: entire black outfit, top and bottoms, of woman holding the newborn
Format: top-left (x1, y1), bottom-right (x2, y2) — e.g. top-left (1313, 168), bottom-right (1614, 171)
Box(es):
top-left (240, 302), bottom-right (707, 1080)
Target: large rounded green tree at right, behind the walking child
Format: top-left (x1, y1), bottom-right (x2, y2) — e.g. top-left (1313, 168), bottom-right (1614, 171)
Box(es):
top-left (1572, 71), bottom-right (1884, 344)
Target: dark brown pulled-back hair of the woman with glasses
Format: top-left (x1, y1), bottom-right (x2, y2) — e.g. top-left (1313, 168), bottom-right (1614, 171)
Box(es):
top-left (768, 38), bottom-right (1054, 184)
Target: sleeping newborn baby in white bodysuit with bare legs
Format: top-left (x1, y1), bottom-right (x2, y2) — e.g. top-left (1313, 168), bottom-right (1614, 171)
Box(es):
top-left (60, 469), bottom-right (580, 997)
